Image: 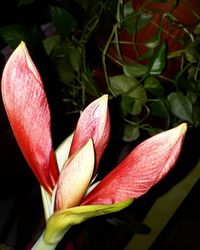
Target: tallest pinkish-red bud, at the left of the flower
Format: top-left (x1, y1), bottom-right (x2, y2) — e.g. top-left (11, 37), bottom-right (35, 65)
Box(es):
top-left (2, 42), bottom-right (58, 193)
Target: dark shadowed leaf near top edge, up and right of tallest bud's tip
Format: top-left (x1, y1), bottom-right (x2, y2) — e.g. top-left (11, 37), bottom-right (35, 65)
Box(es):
top-left (49, 6), bottom-right (77, 38)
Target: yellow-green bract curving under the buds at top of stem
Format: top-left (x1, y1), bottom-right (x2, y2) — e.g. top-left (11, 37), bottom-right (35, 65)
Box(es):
top-left (43, 200), bottom-right (133, 245)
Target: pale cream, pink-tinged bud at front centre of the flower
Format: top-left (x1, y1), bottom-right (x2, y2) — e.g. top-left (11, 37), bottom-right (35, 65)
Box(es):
top-left (55, 139), bottom-right (94, 211)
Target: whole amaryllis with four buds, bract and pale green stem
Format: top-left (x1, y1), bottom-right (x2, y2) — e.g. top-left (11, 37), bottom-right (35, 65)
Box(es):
top-left (2, 42), bottom-right (187, 249)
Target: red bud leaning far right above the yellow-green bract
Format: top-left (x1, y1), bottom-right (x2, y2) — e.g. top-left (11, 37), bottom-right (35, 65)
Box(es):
top-left (81, 123), bottom-right (187, 205)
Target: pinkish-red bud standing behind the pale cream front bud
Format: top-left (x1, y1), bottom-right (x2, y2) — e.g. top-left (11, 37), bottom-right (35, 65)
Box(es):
top-left (69, 95), bottom-right (110, 173)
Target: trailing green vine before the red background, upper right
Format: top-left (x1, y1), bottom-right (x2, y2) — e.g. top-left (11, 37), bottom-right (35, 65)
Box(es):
top-left (97, 1), bottom-right (200, 141)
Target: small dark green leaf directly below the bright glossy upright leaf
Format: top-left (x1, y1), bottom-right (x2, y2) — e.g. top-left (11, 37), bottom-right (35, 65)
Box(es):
top-left (144, 76), bottom-right (165, 97)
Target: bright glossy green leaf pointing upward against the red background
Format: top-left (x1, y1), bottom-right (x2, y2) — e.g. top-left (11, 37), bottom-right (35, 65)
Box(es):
top-left (149, 43), bottom-right (167, 75)
